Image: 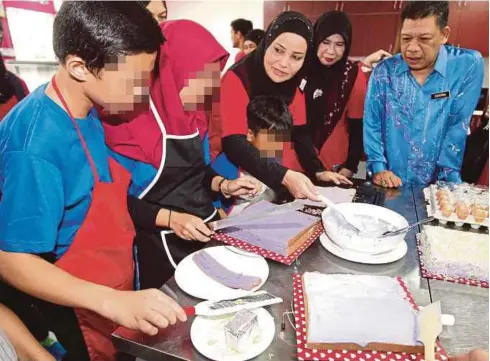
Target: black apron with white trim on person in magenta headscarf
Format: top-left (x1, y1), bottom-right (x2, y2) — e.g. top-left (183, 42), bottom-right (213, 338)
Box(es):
top-left (135, 97), bottom-right (219, 289)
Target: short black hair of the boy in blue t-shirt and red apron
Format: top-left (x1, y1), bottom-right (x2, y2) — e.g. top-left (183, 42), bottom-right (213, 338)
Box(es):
top-left (53, 1), bottom-right (164, 73)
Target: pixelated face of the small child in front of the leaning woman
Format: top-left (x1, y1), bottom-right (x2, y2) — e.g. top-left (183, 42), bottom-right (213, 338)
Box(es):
top-left (247, 129), bottom-right (291, 158)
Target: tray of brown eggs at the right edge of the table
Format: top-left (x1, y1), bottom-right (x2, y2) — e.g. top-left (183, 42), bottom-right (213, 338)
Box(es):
top-left (424, 182), bottom-right (489, 229)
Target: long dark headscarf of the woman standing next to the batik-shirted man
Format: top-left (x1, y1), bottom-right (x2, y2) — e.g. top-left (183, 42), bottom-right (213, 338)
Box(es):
top-left (306, 11), bottom-right (359, 149)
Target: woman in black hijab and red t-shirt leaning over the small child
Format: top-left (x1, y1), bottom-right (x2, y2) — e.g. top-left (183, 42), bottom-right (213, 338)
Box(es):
top-left (220, 11), bottom-right (350, 200)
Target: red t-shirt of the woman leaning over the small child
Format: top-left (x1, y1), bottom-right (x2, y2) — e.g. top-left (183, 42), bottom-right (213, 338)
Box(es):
top-left (220, 71), bottom-right (306, 171)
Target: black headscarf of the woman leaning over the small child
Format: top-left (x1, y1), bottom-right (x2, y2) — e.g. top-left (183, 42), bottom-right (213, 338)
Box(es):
top-left (230, 11), bottom-right (313, 104)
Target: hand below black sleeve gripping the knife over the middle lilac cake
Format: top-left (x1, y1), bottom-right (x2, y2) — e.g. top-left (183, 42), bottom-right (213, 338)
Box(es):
top-left (170, 212), bottom-right (214, 242)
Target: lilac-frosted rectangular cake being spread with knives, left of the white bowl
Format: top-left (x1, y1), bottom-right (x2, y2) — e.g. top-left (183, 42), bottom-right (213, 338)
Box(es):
top-left (226, 201), bottom-right (320, 256)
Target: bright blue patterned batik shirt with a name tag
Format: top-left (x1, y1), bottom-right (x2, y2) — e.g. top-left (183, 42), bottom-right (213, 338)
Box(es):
top-left (364, 46), bottom-right (484, 184)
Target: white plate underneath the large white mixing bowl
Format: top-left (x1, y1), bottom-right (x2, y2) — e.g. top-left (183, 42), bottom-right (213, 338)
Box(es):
top-left (320, 233), bottom-right (408, 264)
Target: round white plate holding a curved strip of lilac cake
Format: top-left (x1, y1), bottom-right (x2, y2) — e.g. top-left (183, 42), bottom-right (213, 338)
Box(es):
top-left (175, 246), bottom-right (269, 301)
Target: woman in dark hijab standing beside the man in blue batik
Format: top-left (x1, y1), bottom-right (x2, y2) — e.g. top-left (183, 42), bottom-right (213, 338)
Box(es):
top-left (305, 11), bottom-right (367, 177)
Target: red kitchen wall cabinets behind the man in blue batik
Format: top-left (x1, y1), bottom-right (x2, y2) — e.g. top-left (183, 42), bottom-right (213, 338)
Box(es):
top-left (264, 0), bottom-right (489, 56)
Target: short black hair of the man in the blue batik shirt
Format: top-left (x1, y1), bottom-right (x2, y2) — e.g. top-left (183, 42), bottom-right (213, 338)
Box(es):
top-left (402, 1), bottom-right (449, 29)
